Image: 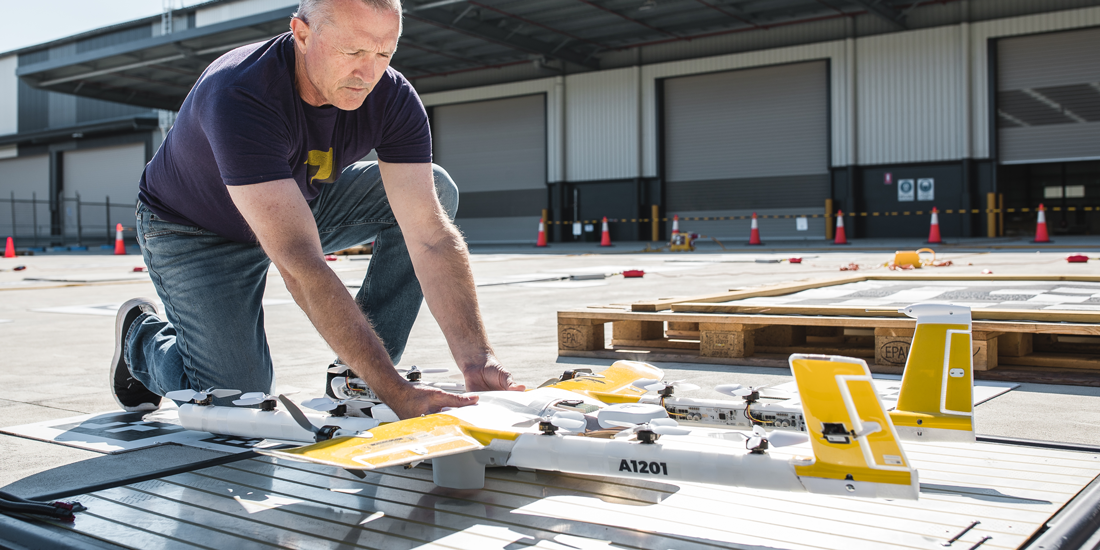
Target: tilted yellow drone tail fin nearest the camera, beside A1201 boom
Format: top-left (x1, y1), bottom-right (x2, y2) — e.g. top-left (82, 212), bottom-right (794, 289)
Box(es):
top-left (790, 354), bottom-right (919, 499)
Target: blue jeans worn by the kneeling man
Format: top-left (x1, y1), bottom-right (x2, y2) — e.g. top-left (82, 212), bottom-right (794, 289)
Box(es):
top-left (123, 162), bottom-right (459, 395)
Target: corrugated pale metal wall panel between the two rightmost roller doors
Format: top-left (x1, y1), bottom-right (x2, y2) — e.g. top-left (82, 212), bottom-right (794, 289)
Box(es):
top-left (856, 25), bottom-right (966, 165)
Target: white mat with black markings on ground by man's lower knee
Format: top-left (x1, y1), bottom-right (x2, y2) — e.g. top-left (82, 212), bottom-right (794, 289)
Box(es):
top-left (0, 406), bottom-right (288, 454)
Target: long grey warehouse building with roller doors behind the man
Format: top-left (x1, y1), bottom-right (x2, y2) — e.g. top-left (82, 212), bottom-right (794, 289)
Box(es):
top-left (0, 0), bottom-right (1100, 244)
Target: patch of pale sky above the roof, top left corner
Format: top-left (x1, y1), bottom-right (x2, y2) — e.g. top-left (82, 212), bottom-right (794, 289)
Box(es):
top-left (0, 0), bottom-right (205, 52)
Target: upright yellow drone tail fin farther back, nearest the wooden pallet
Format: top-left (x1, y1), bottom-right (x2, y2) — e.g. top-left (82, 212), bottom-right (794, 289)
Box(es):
top-left (890, 304), bottom-right (974, 441)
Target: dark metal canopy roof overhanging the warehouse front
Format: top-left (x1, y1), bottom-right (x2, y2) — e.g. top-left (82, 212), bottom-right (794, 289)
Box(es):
top-left (8, 0), bottom-right (1007, 110)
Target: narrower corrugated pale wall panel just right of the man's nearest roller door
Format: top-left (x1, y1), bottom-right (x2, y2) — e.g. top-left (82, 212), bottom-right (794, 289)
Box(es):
top-left (565, 67), bottom-right (640, 182)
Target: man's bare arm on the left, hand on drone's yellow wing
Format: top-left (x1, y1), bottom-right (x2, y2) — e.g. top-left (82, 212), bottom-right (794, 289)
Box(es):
top-left (228, 179), bottom-right (476, 418)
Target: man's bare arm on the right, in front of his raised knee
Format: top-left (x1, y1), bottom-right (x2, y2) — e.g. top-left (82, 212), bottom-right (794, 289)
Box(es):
top-left (378, 162), bottom-right (524, 392)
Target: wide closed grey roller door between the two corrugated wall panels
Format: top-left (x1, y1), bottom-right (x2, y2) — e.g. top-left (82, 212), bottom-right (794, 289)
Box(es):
top-left (663, 62), bottom-right (831, 238)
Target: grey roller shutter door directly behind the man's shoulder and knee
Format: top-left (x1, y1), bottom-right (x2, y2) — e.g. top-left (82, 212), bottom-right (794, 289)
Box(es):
top-left (432, 94), bottom-right (547, 242)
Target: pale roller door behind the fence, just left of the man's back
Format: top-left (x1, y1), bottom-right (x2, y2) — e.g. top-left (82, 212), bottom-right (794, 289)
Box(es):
top-left (62, 143), bottom-right (145, 240)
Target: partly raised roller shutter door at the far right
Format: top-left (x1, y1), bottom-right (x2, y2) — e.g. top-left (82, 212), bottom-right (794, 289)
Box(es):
top-left (997, 29), bottom-right (1100, 164)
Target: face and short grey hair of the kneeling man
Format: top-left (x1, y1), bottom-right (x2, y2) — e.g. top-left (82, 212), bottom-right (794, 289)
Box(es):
top-left (290, 0), bottom-right (400, 111)
